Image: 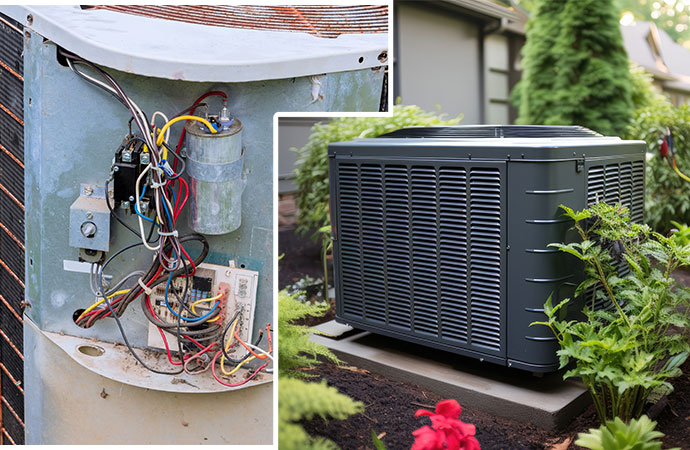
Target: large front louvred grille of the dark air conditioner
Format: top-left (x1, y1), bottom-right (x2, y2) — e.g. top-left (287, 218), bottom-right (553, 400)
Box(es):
top-left (337, 163), bottom-right (502, 351)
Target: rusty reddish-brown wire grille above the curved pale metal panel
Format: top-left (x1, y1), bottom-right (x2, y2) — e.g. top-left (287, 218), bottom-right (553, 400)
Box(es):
top-left (95, 5), bottom-right (388, 38)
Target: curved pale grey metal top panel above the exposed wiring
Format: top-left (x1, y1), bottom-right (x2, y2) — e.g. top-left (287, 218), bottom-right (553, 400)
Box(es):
top-left (2, 5), bottom-right (388, 82)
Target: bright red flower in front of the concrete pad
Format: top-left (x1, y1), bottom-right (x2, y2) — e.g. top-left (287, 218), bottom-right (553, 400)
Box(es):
top-left (412, 400), bottom-right (479, 450)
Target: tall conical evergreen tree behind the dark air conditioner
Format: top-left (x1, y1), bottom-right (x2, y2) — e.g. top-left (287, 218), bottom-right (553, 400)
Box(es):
top-left (513, 0), bottom-right (633, 135)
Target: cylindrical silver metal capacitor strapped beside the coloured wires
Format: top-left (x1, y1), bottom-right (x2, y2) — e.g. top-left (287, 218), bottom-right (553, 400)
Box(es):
top-left (185, 118), bottom-right (245, 235)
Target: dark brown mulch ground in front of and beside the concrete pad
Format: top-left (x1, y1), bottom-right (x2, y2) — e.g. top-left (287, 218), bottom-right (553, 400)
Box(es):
top-left (303, 361), bottom-right (690, 450)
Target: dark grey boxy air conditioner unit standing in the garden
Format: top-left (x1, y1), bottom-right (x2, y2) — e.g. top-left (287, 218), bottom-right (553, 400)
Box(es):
top-left (329, 126), bottom-right (646, 372)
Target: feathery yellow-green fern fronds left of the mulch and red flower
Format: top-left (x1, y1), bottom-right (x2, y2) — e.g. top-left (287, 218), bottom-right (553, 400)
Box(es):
top-left (278, 291), bottom-right (364, 450)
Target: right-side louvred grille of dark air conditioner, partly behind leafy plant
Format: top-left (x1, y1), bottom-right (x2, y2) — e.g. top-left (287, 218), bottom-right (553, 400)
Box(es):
top-left (584, 161), bottom-right (644, 309)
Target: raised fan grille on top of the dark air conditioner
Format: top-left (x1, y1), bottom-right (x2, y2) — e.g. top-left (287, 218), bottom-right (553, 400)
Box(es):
top-left (380, 125), bottom-right (601, 139)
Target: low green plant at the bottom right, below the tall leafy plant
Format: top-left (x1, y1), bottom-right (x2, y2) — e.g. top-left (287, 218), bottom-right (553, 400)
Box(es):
top-left (575, 416), bottom-right (680, 450)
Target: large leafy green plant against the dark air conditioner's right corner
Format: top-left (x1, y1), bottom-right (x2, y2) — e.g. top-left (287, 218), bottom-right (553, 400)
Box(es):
top-left (533, 203), bottom-right (690, 423)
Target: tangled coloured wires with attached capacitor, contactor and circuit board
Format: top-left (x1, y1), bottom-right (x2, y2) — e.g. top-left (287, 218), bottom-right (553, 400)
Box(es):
top-left (59, 49), bottom-right (273, 387)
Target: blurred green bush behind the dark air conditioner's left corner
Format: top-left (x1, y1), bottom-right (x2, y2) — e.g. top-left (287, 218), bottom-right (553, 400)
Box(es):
top-left (294, 104), bottom-right (462, 239)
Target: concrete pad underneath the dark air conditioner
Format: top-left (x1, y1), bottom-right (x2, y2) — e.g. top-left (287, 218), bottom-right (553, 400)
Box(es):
top-left (312, 322), bottom-right (591, 430)
